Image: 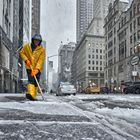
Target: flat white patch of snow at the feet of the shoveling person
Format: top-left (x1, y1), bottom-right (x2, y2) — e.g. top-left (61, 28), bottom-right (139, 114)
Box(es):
top-left (0, 101), bottom-right (81, 116)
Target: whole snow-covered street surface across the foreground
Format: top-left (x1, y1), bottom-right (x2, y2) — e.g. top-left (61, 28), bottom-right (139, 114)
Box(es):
top-left (0, 94), bottom-right (140, 140)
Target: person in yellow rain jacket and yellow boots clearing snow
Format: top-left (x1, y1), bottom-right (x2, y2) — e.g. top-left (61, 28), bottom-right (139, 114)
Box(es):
top-left (20, 34), bottom-right (45, 101)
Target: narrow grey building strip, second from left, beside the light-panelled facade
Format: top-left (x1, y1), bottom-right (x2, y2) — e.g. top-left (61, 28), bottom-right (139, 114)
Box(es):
top-left (10, 0), bottom-right (19, 92)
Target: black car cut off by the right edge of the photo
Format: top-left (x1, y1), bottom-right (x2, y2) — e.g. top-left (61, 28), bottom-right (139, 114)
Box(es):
top-left (123, 82), bottom-right (140, 94)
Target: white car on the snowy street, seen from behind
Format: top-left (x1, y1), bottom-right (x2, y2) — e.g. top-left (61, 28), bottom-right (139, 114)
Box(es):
top-left (56, 84), bottom-right (76, 96)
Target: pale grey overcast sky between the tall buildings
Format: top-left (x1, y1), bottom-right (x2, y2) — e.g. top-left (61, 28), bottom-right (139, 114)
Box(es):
top-left (41, 0), bottom-right (76, 70)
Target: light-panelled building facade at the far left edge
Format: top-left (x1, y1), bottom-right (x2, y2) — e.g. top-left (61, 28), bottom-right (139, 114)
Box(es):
top-left (0, 0), bottom-right (14, 92)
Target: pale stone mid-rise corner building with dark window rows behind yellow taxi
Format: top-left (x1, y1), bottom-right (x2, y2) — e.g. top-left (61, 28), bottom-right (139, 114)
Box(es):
top-left (72, 32), bottom-right (105, 89)
